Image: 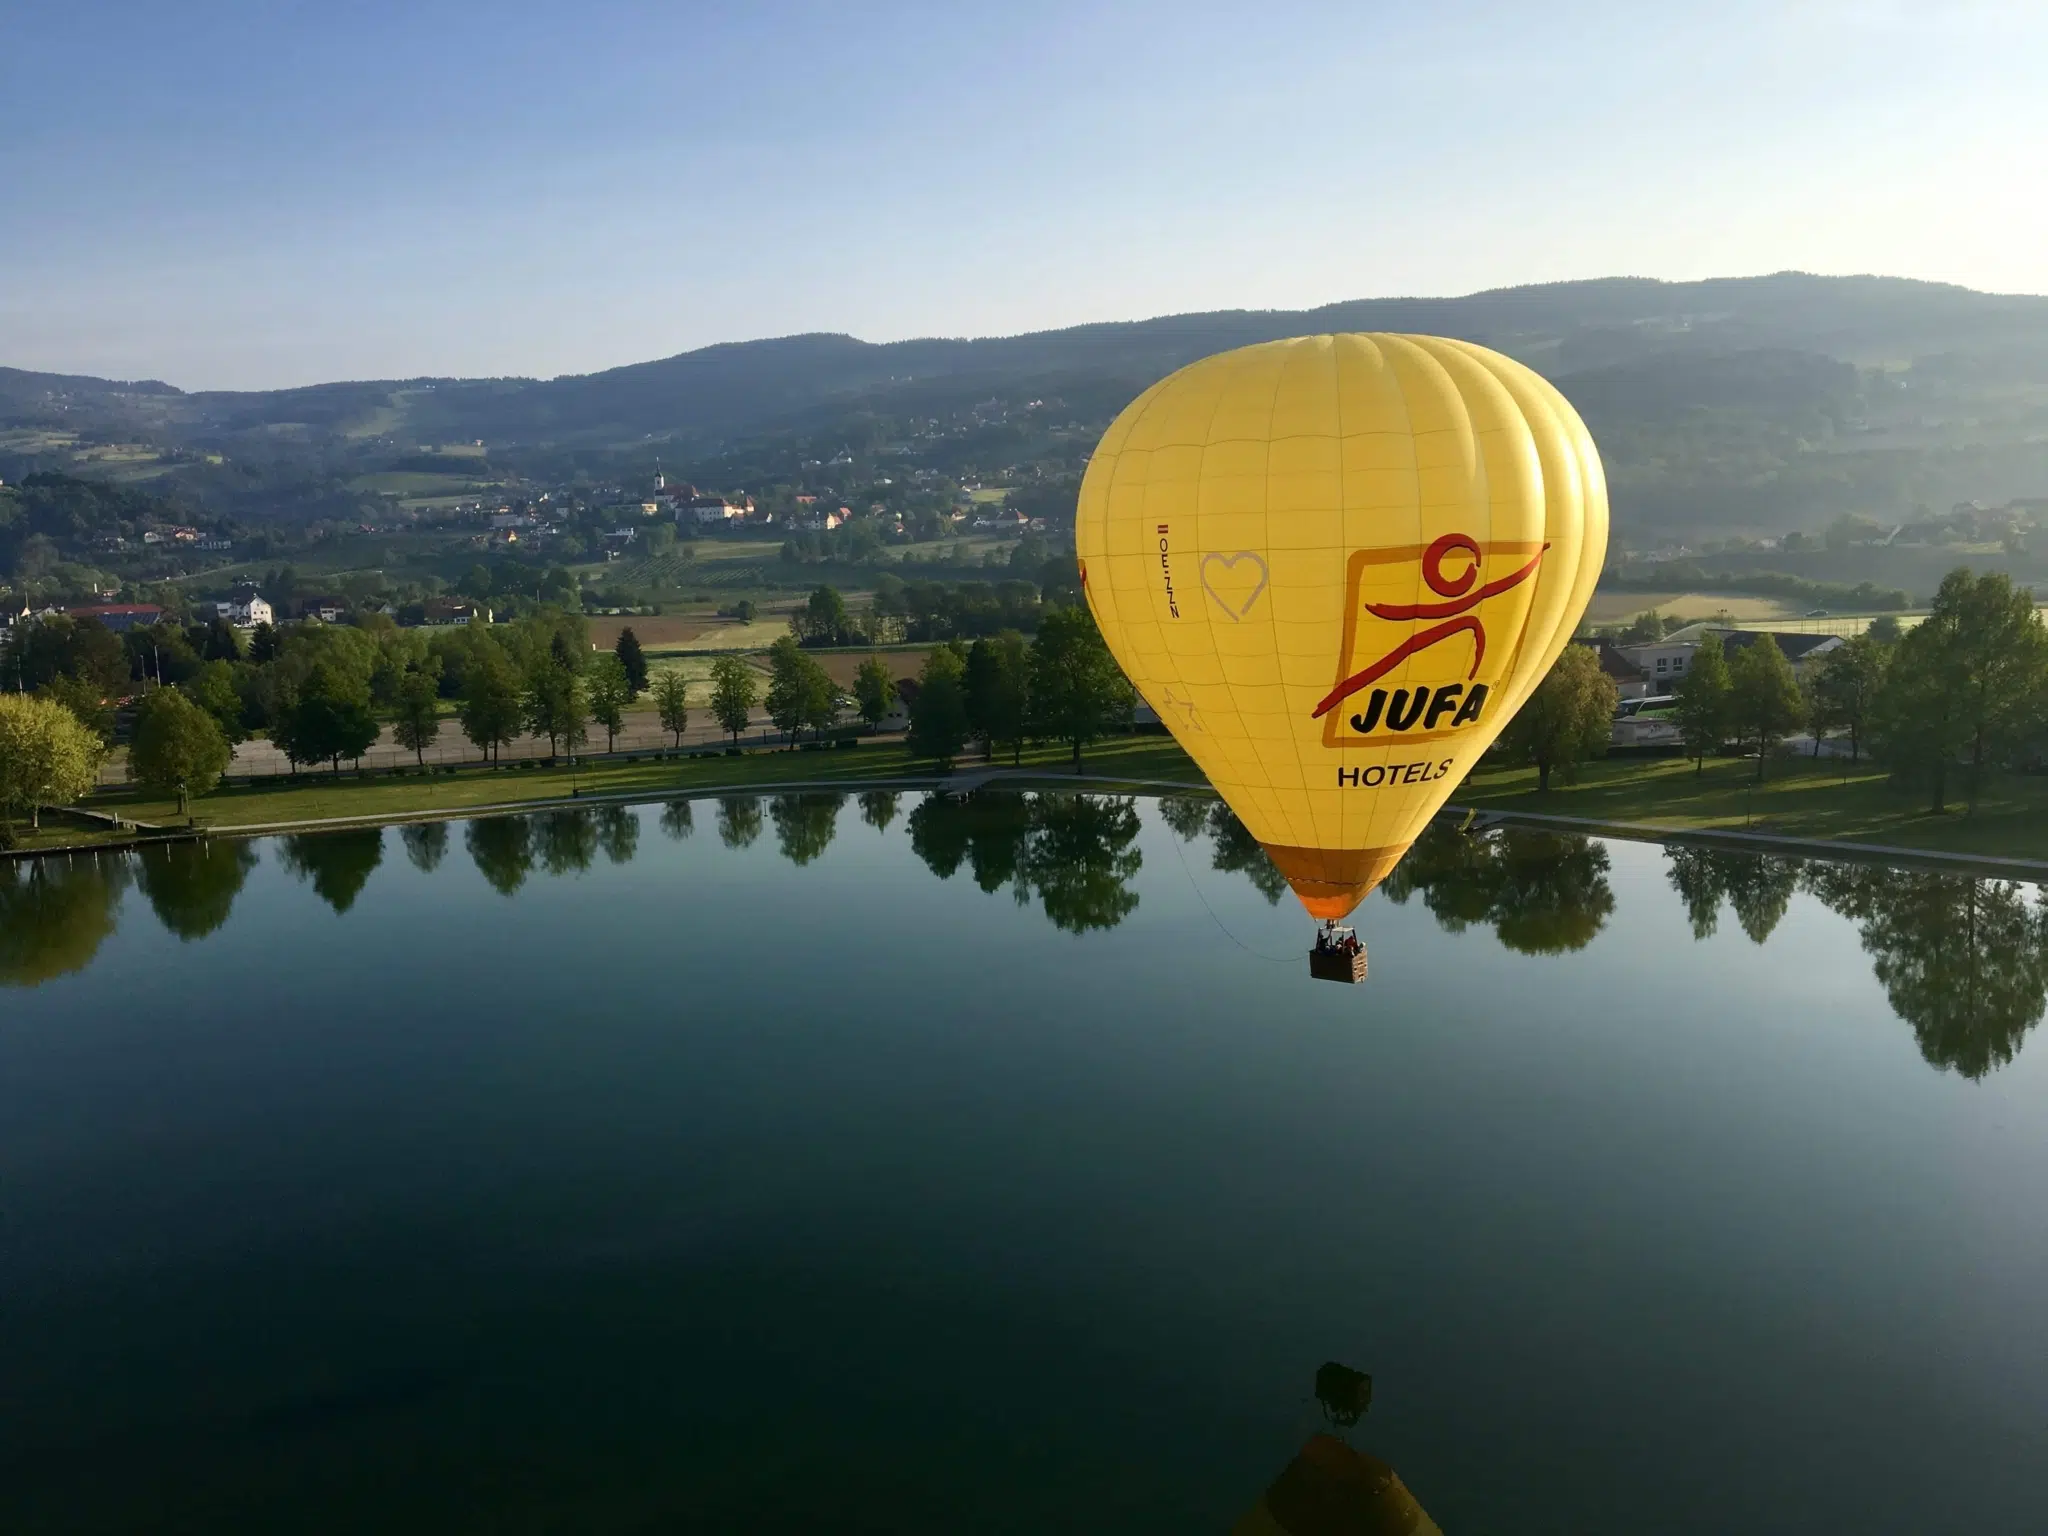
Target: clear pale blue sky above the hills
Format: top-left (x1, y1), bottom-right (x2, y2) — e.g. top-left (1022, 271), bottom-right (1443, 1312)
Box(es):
top-left (0, 0), bottom-right (2048, 387)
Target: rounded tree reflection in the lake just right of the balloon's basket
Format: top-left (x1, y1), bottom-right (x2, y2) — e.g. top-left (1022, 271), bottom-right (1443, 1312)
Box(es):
top-left (1380, 821), bottom-right (1614, 954)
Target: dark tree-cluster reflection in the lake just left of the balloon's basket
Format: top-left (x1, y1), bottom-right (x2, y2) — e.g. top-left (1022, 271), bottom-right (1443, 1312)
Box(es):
top-left (909, 791), bottom-right (1143, 934)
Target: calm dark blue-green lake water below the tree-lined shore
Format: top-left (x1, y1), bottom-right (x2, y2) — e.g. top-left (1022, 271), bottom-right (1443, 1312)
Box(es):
top-left (0, 793), bottom-right (2048, 1536)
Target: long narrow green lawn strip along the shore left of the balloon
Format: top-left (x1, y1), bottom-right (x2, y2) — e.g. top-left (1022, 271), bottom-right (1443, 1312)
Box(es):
top-left (90, 735), bottom-right (1202, 843)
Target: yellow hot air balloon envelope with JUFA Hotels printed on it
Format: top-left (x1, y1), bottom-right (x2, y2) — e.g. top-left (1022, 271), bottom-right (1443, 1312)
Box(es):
top-left (1077, 334), bottom-right (1608, 933)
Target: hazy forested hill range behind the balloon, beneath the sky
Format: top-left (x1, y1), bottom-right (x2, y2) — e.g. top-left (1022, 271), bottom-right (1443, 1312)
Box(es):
top-left (0, 272), bottom-right (2048, 541)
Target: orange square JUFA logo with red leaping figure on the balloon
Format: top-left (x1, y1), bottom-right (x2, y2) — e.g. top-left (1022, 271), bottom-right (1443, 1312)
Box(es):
top-left (1313, 532), bottom-right (1548, 745)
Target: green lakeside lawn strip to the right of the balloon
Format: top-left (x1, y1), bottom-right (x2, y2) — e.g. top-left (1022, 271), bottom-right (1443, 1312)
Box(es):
top-left (1452, 758), bottom-right (2048, 858)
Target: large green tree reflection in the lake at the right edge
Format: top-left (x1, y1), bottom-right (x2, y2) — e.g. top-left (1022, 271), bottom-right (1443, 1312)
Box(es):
top-left (1806, 864), bottom-right (2048, 1077)
